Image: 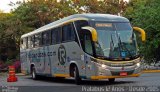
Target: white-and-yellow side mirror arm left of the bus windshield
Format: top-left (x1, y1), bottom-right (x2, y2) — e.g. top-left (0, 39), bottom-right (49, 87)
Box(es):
top-left (82, 26), bottom-right (98, 42)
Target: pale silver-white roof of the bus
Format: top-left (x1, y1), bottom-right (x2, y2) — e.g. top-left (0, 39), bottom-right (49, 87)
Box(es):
top-left (21, 13), bottom-right (129, 38)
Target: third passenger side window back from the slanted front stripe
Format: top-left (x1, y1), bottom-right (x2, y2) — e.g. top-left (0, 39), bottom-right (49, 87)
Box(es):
top-left (42, 31), bottom-right (51, 46)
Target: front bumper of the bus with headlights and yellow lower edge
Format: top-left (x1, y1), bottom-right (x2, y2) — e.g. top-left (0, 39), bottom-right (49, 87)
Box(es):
top-left (90, 59), bottom-right (141, 79)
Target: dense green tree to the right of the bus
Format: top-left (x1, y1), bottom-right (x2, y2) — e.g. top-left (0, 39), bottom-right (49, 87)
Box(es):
top-left (124, 0), bottom-right (160, 63)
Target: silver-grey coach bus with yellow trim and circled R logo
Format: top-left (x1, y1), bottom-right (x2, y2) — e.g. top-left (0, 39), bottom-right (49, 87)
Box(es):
top-left (20, 14), bottom-right (145, 84)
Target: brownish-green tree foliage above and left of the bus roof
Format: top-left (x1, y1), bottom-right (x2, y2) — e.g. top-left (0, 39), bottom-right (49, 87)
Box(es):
top-left (0, 0), bottom-right (125, 58)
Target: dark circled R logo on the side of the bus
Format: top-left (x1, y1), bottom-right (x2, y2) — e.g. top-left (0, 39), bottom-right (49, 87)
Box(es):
top-left (58, 45), bottom-right (66, 65)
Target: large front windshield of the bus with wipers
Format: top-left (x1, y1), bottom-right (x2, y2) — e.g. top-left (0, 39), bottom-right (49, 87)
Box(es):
top-left (95, 22), bottom-right (138, 60)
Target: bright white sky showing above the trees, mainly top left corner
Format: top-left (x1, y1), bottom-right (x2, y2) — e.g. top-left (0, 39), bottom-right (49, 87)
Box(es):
top-left (0, 0), bottom-right (128, 13)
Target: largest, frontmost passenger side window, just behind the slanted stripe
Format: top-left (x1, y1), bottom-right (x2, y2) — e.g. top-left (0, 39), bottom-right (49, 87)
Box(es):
top-left (62, 23), bottom-right (75, 42)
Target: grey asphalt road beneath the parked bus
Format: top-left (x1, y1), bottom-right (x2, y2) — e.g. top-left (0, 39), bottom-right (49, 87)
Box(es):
top-left (0, 73), bottom-right (160, 92)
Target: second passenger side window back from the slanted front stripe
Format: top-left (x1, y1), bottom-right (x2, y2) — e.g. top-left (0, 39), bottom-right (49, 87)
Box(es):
top-left (51, 27), bottom-right (61, 44)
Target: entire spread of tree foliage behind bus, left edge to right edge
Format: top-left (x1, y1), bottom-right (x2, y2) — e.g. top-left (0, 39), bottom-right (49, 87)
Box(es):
top-left (0, 0), bottom-right (160, 61)
